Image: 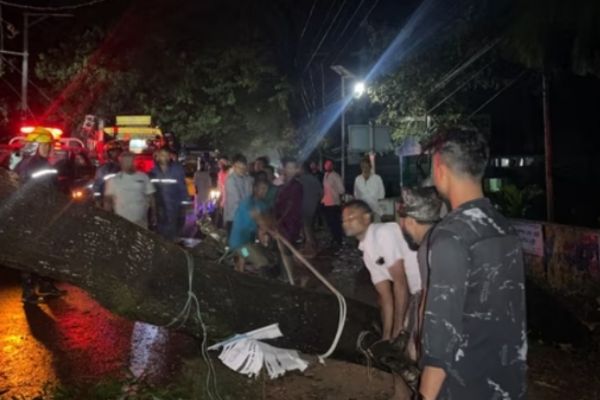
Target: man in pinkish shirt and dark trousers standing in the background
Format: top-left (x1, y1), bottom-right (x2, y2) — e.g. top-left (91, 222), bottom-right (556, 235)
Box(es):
top-left (321, 160), bottom-right (346, 247)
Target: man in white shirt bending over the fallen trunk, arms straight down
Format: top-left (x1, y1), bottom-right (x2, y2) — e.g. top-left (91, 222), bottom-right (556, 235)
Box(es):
top-left (342, 200), bottom-right (422, 400)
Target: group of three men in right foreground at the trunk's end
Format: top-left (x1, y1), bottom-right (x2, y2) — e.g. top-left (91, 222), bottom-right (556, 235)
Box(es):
top-left (343, 129), bottom-right (527, 400)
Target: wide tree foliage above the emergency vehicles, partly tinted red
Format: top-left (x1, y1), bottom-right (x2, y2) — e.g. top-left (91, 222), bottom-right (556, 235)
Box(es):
top-left (36, 25), bottom-right (292, 155)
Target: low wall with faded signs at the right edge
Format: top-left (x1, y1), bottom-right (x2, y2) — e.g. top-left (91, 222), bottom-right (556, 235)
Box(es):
top-left (514, 220), bottom-right (600, 297)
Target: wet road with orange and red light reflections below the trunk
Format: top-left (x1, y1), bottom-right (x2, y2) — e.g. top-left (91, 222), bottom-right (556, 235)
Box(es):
top-left (0, 268), bottom-right (196, 398)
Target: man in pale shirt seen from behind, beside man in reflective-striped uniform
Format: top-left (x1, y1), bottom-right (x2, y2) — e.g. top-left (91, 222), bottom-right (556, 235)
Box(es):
top-left (104, 152), bottom-right (156, 228)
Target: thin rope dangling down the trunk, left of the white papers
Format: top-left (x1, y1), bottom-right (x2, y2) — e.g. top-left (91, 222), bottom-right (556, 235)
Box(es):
top-left (165, 248), bottom-right (222, 400)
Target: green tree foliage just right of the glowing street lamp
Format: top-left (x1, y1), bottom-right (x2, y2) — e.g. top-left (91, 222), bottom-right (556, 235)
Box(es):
top-left (370, 2), bottom-right (504, 141)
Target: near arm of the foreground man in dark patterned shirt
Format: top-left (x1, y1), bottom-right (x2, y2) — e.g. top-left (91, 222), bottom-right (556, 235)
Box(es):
top-left (419, 230), bottom-right (469, 400)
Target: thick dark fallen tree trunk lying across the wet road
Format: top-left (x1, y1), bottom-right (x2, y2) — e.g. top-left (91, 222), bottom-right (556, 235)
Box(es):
top-left (0, 170), bottom-right (379, 361)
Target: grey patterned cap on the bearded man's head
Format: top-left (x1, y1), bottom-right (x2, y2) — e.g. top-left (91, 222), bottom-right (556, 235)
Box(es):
top-left (398, 186), bottom-right (442, 223)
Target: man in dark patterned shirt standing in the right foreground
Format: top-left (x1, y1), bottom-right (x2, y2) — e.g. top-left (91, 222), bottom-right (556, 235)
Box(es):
top-left (420, 129), bottom-right (527, 400)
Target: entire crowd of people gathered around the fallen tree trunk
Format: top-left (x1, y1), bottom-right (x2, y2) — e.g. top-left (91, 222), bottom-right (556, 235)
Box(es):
top-left (11, 129), bottom-right (527, 400)
